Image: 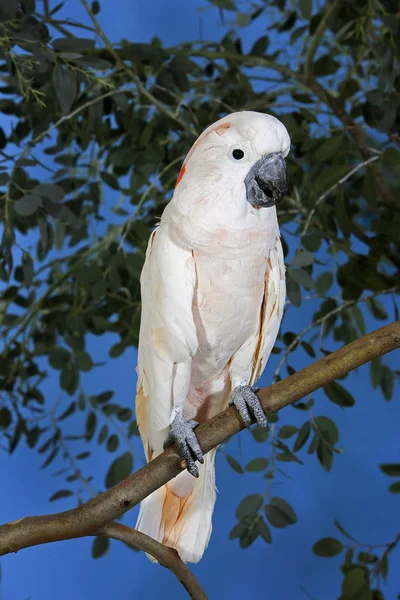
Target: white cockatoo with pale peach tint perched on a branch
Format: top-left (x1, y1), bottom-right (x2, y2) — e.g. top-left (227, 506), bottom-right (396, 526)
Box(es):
top-left (136, 111), bottom-right (290, 562)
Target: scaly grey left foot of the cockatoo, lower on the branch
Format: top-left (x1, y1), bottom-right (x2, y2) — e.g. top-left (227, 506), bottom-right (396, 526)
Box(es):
top-left (164, 409), bottom-right (204, 477)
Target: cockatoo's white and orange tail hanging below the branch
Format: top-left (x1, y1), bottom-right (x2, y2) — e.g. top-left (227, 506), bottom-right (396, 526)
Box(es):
top-left (136, 449), bottom-right (216, 563)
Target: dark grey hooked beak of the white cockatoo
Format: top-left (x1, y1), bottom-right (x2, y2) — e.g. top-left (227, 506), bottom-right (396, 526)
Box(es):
top-left (244, 152), bottom-right (288, 208)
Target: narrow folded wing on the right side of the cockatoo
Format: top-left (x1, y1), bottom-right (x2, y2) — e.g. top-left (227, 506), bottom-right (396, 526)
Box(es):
top-left (250, 237), bottom-right (286, 385)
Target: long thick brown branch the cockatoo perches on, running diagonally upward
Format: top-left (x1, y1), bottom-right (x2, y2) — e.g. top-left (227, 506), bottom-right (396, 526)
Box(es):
top-left (0, 321), bottom-right (400, 556)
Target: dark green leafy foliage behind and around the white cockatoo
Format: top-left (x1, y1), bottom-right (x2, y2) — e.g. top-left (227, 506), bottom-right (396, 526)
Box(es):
top-left (0, 0), bottom-right (400, 600)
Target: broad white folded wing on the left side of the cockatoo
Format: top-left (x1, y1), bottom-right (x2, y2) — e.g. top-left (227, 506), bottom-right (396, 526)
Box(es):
top-left (136, 223), bottom-right (198, 453)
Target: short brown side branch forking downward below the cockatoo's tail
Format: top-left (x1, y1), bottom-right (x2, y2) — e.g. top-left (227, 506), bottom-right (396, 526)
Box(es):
top-left (99, 522), bottom-right (207, 600)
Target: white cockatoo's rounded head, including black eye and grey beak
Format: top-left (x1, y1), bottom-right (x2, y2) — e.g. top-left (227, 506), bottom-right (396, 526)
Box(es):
top-left (176, 111), bottom-right (290, 210)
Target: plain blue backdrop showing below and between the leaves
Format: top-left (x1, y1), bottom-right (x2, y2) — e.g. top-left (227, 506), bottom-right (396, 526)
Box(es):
top-left (0, 0), bottom-right (400, 600)
